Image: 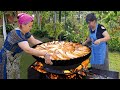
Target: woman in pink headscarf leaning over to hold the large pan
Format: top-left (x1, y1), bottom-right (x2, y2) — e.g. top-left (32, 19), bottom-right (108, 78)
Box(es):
top-left (0, 13), bottom-right (52, 79)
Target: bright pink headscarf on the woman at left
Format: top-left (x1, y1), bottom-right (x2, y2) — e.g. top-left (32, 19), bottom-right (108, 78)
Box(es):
top-left (17, 13), bottom-right (34, 24)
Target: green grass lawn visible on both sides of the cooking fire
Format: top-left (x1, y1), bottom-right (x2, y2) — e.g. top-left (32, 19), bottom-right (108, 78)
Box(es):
top-left (20, 52), bottom-right (120, 79)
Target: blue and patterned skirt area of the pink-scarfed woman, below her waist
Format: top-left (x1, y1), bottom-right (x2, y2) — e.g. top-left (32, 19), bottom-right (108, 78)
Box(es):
top-left (0, 48), bottom-right (21, 79)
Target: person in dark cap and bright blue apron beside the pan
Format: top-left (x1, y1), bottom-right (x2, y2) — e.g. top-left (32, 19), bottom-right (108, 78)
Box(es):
top-left (83, 13), bottom-right (110, 70)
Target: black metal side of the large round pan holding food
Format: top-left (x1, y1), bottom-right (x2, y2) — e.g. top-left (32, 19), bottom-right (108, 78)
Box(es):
top-left (32, 43), bottom-right (91, 69)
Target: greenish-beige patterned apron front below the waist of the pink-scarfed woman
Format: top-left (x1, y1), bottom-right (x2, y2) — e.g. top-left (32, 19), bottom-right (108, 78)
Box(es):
top-left (6, 51), bottom-right (22, 79)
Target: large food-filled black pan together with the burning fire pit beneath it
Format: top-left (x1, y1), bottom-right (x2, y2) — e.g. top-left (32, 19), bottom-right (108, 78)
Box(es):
top-left (28, 41), bottom-right (119, 79)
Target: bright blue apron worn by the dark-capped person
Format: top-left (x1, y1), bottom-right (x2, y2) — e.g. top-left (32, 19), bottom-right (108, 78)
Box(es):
top-left (90, 24), bottom-right (106, 64)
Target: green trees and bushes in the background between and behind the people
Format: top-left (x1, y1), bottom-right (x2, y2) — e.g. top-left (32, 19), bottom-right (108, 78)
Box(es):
top-left (0, 11), bottom-right (120, 51)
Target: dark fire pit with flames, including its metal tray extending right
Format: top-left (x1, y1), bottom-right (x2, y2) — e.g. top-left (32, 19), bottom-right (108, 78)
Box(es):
top-left (28, 59), bottom-right (119, 79)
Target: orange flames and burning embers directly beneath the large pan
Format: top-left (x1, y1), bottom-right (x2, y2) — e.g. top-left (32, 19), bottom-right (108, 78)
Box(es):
top-left (31, 59), bottom-right (89, 79)
